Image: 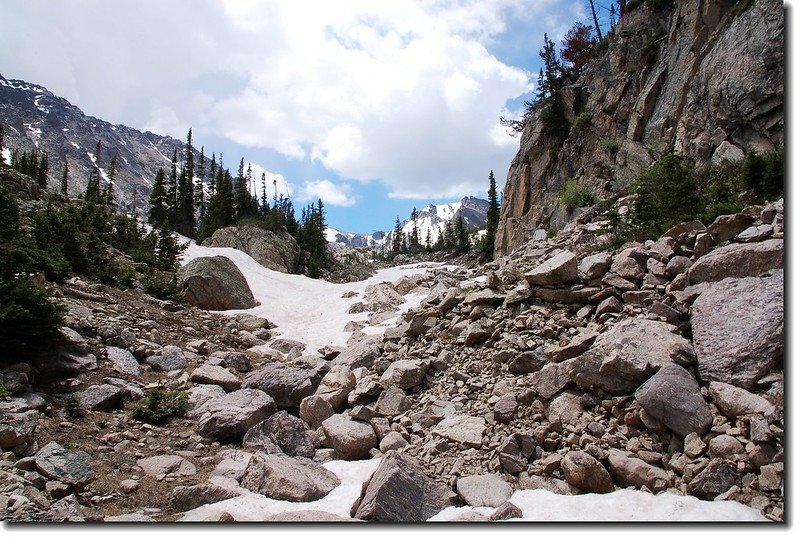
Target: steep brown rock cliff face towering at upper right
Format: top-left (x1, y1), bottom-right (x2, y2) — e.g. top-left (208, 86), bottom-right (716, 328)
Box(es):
top-left (495, 0), bottom-right (785, 255)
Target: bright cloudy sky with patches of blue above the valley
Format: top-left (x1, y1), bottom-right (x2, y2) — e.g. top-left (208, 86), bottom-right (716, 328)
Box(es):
top-left (0, 0), bottom-right (608, 232)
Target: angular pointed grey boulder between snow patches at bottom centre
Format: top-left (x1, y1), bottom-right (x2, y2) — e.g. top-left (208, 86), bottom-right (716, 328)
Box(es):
top-left (352, 451), bottom-right (450, 523)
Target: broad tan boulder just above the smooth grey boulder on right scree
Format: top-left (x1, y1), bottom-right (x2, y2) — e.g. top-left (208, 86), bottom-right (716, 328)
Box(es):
top-left (564, 318), bottom-right (696, 394)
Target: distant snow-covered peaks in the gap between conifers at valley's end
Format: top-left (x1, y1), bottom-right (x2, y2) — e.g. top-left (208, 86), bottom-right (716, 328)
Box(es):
top-left (326, 196), bottom-right (488, 250)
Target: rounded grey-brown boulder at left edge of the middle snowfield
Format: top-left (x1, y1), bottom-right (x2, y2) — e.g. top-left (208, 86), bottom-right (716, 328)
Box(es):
top-left (178, 255), bottom-right (258, 310)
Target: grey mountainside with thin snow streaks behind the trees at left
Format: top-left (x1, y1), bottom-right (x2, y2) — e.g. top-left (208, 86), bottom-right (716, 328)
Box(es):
top-left (0, 75), bottom-right (191, 209)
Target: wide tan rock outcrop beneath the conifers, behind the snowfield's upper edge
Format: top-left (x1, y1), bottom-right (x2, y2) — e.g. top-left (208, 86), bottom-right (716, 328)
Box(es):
top-left (203, 226), bottom-right (300, 273)
